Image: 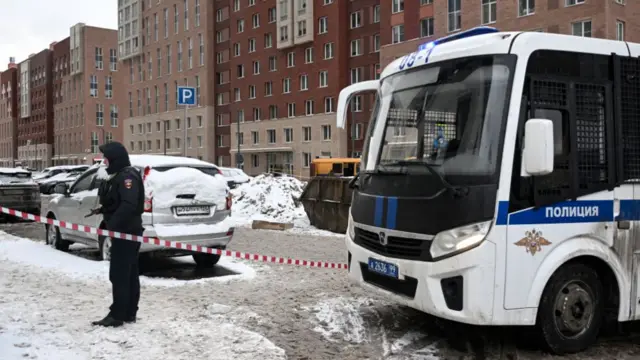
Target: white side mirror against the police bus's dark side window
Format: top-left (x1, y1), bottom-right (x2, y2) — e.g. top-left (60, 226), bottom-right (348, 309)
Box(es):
top-left (521, 119), bottom-right (554, 176)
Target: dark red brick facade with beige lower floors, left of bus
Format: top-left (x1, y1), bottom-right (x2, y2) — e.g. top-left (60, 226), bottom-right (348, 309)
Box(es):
top-left (220, 0), bottom-right (380, 176)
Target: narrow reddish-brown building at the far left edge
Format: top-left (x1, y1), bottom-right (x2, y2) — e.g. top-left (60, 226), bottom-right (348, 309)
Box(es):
top-left (0, 58), bottom-right (18, 167)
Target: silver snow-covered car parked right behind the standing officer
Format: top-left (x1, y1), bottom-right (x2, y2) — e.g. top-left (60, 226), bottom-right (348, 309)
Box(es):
top-left (45, 155), bottom-right (234, 267)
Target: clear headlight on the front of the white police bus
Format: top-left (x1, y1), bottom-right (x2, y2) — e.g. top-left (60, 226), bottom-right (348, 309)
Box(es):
top-left (431, 221), bottom-right (492, 259)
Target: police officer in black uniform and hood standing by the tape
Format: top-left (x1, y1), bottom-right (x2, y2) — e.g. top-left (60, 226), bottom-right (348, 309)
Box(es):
top-left (91, 142), bottom-right (144, 327)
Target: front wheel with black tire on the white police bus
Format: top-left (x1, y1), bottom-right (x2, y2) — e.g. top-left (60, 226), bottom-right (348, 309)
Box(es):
top-left (537, 263), bottom-right (604, 355)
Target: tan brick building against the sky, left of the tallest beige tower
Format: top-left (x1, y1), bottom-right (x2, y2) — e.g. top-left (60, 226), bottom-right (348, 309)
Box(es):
top-left (52, 23), bottom-right (126, 165)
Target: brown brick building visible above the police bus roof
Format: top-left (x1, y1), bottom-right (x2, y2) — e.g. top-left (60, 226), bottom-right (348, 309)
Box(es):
top-left (380, 0), bottom-right (640, 67)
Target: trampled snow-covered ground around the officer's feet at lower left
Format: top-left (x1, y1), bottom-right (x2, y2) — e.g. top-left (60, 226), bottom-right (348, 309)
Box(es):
top-left (0, 232), bottom-right (286, 360)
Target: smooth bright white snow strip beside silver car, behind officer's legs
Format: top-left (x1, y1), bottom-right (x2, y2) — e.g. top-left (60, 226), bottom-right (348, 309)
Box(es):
top-left (0, 231), bottom-right (256, 287)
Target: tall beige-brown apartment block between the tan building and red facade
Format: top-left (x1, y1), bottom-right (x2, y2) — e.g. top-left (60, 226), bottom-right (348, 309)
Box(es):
top-left (118, 0), bottom-right (215, 161)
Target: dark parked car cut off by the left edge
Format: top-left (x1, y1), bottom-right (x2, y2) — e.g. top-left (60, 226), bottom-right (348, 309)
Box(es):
top-left (0, 168), bottom-right (41, 219)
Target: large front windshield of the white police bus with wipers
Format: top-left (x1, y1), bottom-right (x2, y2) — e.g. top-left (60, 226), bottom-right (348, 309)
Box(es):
top-left (367, 55), bottom-right (515, 185)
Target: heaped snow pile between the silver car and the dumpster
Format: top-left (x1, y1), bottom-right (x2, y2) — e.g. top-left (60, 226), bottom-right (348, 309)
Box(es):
top-left (231, 174), bottom-right (307, 222)
